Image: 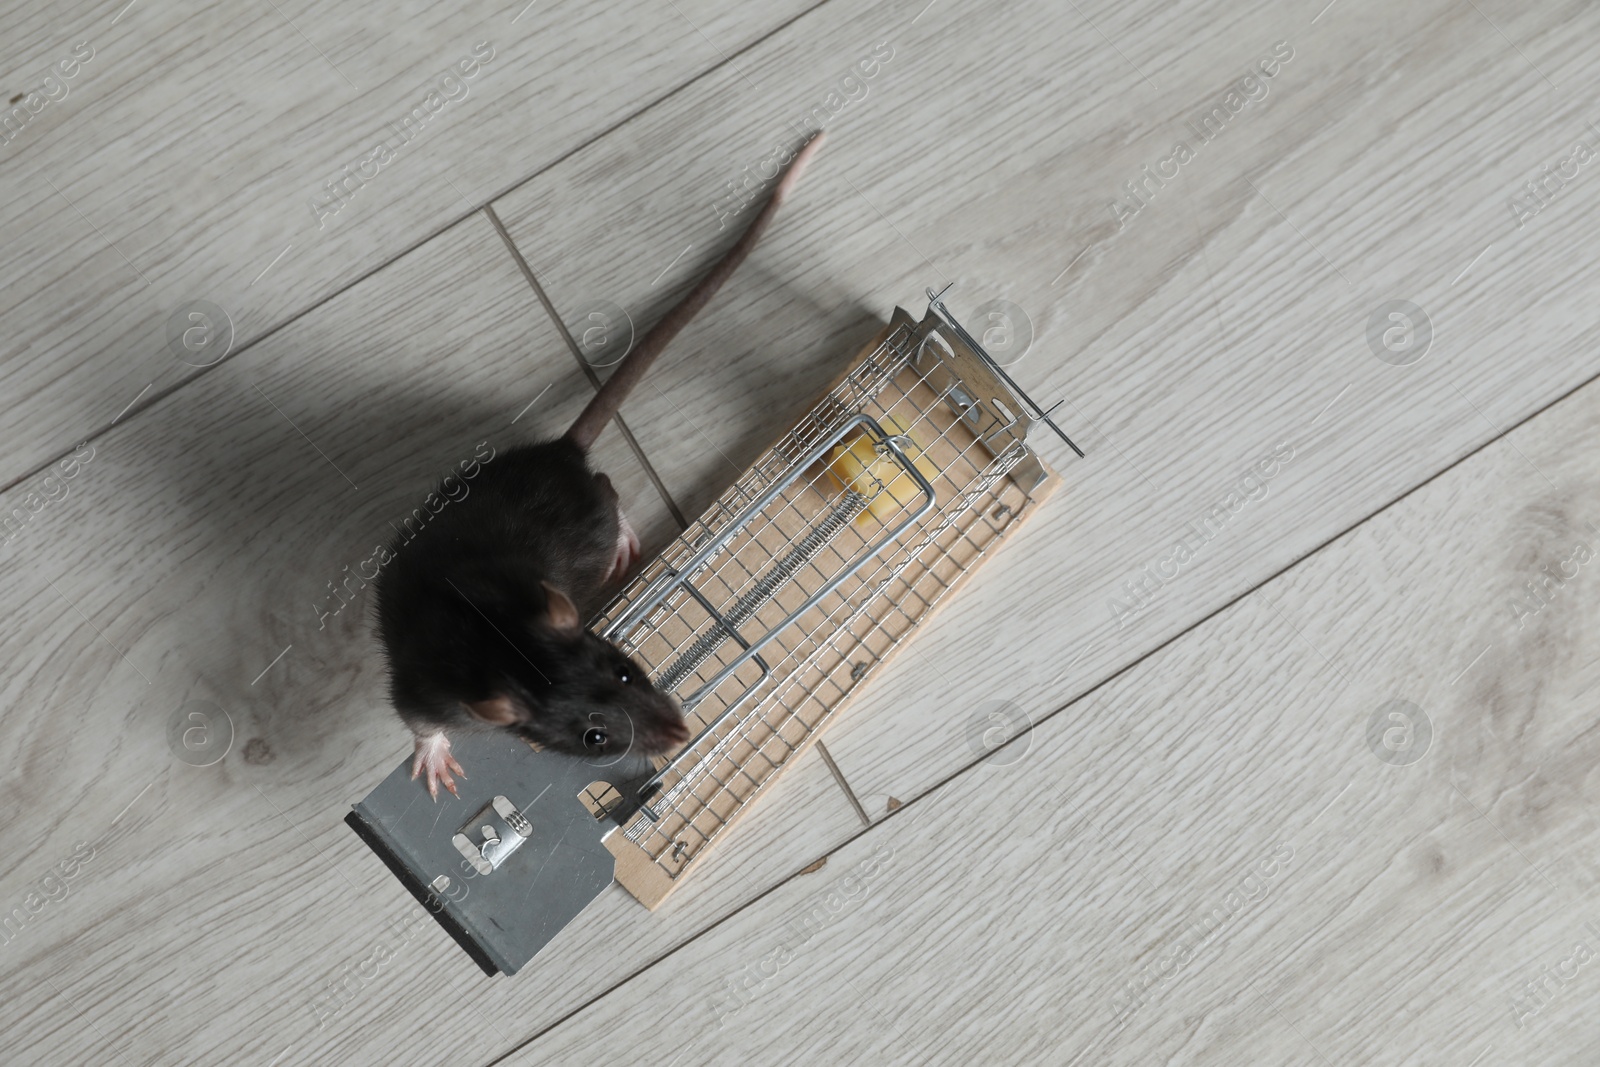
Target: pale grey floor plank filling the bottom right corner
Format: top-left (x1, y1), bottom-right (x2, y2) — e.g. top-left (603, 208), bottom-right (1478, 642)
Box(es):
top-left (504, 303), bottom-right (1600, 1065)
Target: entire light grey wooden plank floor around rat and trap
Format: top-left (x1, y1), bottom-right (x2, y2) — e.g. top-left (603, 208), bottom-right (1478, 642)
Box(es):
top-left (0, 0), bottom-right (1600, 1067)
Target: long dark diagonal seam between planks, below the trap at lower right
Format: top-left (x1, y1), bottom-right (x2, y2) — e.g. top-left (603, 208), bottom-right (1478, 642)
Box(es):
top-left (483, 363), bottom-right (1600, 1067)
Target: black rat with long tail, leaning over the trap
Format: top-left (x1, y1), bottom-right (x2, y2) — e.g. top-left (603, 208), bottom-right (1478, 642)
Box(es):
top-left (374, 133), bottom-right (822, 800)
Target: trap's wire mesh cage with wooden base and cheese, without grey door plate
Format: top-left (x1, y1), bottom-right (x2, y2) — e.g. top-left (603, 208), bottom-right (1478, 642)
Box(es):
top-left (586, 290), bottom-right (1083, 907)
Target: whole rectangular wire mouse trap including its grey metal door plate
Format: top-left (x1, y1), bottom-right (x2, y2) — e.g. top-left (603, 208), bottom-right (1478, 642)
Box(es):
top-left (347, 290), bottom-right (1083, 974)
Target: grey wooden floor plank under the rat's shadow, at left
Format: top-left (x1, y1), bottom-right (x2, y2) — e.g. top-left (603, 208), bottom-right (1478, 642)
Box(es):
top-left (0, 216), bottom-right (838, 1067)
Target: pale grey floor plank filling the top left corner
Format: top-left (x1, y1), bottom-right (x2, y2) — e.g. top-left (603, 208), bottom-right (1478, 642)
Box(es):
top-left (0, 0), bottom-right (808, 485)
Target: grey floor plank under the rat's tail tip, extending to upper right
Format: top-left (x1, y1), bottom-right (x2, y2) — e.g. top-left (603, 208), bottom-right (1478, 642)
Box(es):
top-left (483, 0), bottom-right (1600, 838)
